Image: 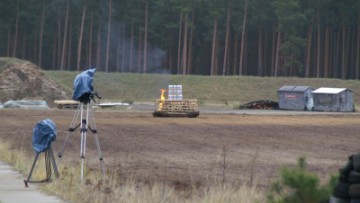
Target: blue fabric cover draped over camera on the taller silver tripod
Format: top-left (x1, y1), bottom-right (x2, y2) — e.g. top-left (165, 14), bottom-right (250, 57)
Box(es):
top-left (72, 68), bottom-right (96, 101)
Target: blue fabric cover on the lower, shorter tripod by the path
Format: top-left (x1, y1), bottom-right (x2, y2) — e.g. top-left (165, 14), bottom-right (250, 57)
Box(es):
top-left (32, 119), bottom-right (56, 153)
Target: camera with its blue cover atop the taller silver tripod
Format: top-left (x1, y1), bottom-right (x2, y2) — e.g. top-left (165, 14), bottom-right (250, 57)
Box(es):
top-left (72, 68), bottom-right (101, 104)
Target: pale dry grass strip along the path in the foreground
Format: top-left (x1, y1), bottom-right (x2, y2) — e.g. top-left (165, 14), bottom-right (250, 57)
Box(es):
top-left (0, 141), bottom-right (265, 203)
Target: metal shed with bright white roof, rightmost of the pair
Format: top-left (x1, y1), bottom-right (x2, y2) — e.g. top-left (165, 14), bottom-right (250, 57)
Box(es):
top-left (313, 87), bottom-right (355, 112)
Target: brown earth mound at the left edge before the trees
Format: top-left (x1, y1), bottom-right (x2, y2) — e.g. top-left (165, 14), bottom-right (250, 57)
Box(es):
top-left (0, 58), bottom-right (68, 103)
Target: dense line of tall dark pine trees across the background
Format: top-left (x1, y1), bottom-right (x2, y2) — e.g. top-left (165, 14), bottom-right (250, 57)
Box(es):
top-left (0, 0), bottom-right (360, 79)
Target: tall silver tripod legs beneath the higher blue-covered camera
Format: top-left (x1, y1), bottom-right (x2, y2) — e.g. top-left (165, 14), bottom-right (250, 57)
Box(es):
top-left (58, 99), bottom-right (105, 181)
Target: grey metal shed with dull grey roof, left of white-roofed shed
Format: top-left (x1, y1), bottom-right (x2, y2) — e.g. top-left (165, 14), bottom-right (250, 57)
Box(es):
top-left (278, 86), bottom-right (314, 110)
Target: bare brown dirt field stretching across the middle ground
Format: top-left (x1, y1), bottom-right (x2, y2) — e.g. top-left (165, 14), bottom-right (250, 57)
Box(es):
top-left (0, 109), bottom-right (360, 190)
